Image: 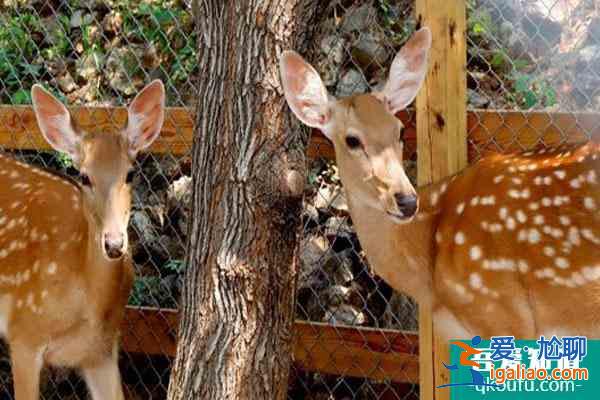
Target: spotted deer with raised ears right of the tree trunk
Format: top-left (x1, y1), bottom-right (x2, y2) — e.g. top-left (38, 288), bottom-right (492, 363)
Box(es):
top-left (280, 28), bottom-right (600, 339)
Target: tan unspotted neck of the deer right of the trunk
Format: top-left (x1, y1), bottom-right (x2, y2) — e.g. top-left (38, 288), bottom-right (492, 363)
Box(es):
top-left (347, 190), bottom-right (434, 304)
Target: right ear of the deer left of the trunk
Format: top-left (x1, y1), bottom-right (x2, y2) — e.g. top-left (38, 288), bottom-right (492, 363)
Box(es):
top-left (124, 79), bottom-right (165, 158)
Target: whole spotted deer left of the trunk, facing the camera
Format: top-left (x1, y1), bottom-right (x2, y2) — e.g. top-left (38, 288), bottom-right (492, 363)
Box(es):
top-left (0, 81), bottom-right (165, 400)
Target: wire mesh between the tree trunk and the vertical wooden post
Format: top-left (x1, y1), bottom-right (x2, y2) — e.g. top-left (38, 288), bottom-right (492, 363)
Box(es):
top-left (289, 0), bottom-right (418, 399)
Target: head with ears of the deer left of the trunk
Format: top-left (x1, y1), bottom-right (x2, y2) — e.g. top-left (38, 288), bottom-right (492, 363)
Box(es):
top-left (31, 80), bottom-right (165, 260)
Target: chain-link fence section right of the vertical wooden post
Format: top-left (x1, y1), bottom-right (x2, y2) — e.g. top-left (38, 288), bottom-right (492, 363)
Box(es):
top-left (467, 0), bottom-right (600, 159)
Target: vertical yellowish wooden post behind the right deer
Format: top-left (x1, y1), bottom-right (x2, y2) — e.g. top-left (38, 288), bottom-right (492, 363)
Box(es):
top-left (416, 0), bottom-right (467, 400)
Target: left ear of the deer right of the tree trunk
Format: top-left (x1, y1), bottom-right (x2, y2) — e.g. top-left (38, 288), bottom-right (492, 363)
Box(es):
top-left (279, 51), bottom-right (331, 134)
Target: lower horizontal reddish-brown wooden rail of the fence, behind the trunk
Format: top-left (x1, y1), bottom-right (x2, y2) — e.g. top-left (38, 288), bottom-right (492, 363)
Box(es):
top-left (121, 307), bottom-right (419, 383)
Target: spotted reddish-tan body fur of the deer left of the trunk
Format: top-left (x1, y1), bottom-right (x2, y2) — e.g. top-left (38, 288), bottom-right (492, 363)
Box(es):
top-left (0, 145), bottom-right (133, 400)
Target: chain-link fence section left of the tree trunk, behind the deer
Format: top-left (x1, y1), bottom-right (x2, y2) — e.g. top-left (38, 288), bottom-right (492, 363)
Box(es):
top-left (0, 0), bottom-right (192, 400)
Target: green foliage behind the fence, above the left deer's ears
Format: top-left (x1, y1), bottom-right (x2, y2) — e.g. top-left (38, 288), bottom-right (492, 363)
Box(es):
top-left (0, 0), bottom-right (197, 104)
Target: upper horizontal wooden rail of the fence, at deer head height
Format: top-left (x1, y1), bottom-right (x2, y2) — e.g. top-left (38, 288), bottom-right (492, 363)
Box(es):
top-left (0, 106), bottom-right (600, 160)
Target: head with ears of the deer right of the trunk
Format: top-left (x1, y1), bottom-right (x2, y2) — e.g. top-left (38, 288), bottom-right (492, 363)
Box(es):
top-left (280, 28), bottom-right (431, 223)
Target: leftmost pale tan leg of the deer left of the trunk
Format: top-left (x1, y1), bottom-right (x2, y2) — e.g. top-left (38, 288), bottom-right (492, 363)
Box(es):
top-left (10, 343), bottom-right (43, 400)
